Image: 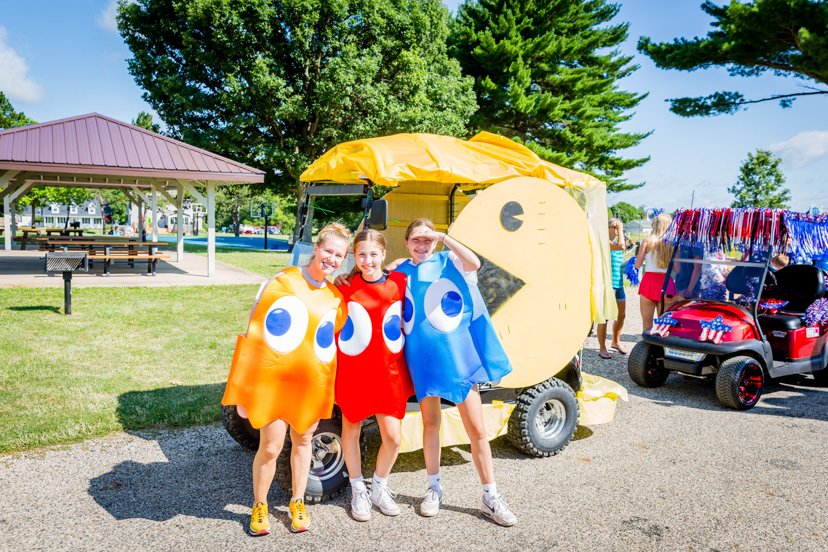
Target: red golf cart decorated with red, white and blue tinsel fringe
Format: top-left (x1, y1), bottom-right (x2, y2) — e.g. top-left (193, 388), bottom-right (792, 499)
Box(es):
top-left (627, 209), bottom-right (828, 410)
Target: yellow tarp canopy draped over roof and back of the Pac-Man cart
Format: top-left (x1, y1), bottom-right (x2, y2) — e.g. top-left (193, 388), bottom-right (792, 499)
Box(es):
top-left (300, 132), bottom-right (618, 323)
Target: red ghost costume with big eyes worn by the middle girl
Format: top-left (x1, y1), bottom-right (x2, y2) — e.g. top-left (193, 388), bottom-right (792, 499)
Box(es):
top-left (336, 272), bottom-right (414, 423)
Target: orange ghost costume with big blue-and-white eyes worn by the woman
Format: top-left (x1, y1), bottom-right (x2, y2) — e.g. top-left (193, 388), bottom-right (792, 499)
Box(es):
top-left (221, 267), bottom-right (348, 433)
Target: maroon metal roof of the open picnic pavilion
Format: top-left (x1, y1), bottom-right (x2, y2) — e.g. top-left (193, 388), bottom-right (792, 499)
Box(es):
top-left (0, 113), bottom-right (264, 186)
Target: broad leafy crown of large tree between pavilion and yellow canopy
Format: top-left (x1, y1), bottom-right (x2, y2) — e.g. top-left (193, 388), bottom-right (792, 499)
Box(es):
top-left (117, 0), bottom-right (476, 235)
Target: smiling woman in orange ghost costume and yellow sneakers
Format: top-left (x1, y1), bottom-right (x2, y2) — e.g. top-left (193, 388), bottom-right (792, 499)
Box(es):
top-left (221, 223), bottom-right (350, 536)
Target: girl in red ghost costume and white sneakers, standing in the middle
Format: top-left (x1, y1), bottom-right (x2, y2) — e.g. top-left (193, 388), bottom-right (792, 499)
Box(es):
top-left (336, 230), bottom-right (414, 521)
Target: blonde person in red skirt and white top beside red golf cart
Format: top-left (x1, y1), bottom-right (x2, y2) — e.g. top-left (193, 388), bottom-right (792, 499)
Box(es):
top-left (635, 213), bottom-right (676, 332)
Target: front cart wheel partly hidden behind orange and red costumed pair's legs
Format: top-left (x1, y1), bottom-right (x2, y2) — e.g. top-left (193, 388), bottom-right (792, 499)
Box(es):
top-left (276, 406), bottom-right (367, 502)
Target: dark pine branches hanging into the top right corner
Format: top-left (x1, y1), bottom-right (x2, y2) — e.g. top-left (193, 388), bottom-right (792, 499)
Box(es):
top-left (638, 0), bottom-right (828, 117)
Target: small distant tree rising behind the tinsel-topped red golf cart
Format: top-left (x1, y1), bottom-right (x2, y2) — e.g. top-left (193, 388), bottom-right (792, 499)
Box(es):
top-left (727, 149), bottom-right (791, 209)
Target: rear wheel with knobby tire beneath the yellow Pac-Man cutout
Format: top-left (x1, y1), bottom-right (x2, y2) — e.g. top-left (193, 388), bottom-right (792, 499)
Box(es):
top-left (509, 378), bottom-right (580, 457)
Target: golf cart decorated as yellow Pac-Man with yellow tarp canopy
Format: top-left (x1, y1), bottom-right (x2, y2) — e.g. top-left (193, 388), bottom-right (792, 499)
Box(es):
top-left (222, 133), bottom-right (626, 502)
